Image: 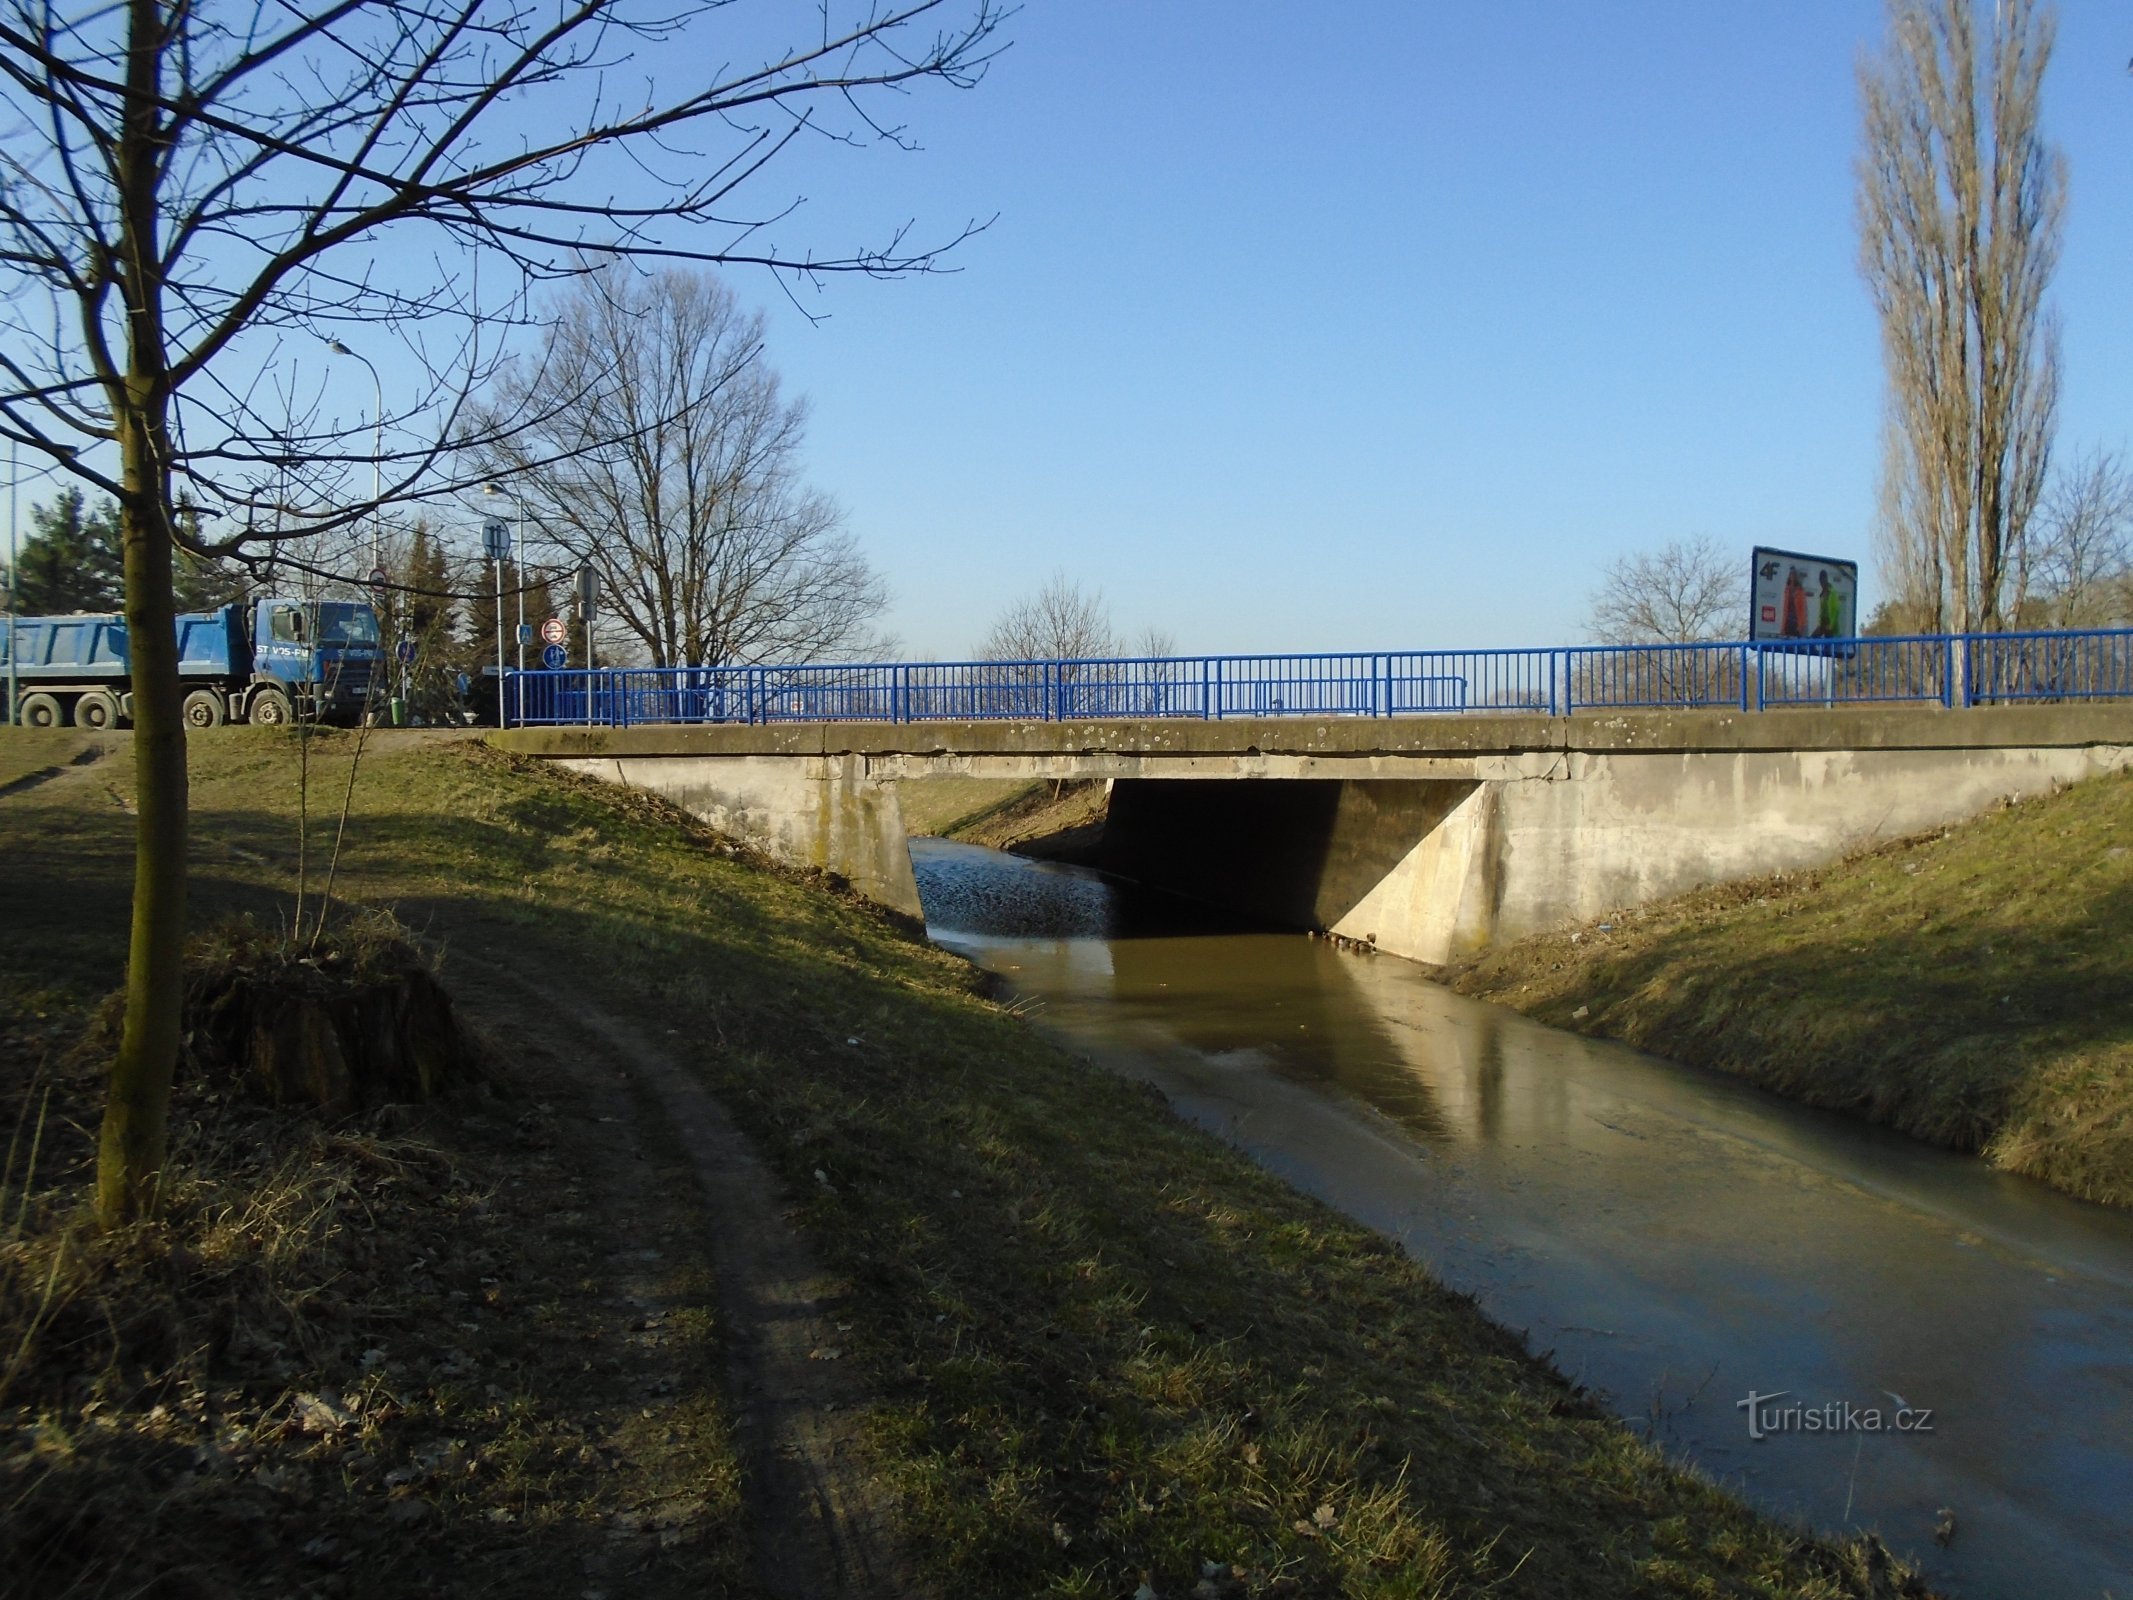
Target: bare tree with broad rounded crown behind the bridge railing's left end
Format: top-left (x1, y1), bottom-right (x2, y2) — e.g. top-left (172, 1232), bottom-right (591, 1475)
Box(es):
top-left (484, 262), bottom-right (887, 666)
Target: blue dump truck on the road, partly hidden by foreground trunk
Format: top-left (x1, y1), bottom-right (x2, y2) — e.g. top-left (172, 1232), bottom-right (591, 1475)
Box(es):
top-left (0, 599), bottom-right (382, 727)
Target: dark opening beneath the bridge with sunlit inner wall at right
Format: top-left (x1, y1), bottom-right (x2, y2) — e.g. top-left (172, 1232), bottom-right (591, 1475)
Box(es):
top-left (1094, 779), bottom-right (1480, 958)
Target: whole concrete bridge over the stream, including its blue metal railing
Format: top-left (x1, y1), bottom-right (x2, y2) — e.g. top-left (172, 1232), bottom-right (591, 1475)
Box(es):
top-left (493, 629), bottom-right (2133, 962)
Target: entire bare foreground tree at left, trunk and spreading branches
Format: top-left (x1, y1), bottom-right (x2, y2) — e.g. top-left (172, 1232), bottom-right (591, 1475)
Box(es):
top-left (0, 0), bottom-right (998, 1220)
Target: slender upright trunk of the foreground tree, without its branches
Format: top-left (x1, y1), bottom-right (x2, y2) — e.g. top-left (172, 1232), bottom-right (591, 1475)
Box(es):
top-left (96, 0), bottom-right (188, 1227)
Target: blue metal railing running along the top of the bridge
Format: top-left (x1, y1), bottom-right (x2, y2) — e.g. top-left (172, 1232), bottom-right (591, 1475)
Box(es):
top-left (506, 627), bottom-right (2133, 727)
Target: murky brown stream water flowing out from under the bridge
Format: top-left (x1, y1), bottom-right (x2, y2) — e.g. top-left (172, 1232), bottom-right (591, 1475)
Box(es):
top-left (911, 838), bottom-right (2133, 1600)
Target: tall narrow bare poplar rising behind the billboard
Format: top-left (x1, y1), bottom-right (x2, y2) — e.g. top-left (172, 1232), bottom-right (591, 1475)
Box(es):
top-left (1858, 0), bottom-right (2067, 631)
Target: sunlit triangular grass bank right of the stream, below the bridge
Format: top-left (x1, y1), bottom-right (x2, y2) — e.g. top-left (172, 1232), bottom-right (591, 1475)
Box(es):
top-left (1446, 774), bottom-right (2133, 1205)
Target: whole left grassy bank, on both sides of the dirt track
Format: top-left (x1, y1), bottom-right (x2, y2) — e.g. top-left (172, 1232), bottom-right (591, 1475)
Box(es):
top-left (0, 730), bottom-right (1928, 1598)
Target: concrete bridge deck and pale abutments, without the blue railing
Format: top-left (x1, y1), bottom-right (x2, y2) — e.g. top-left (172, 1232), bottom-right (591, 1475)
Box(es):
top-left (503, 704), bottom-right (2133, 962)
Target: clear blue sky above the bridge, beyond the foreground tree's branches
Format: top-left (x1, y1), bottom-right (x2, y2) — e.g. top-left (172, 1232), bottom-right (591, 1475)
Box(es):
top-left (736, 0), bottom-right (2133, 655)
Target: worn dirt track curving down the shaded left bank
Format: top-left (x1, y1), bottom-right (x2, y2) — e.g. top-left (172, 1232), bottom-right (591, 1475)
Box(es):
top-left (454, 941), bottom-right (911, 1600)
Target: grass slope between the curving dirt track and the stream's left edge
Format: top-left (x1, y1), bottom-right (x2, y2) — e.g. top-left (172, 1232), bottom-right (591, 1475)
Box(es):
top-left (0, 730), bottom-right (1936, 1598)
